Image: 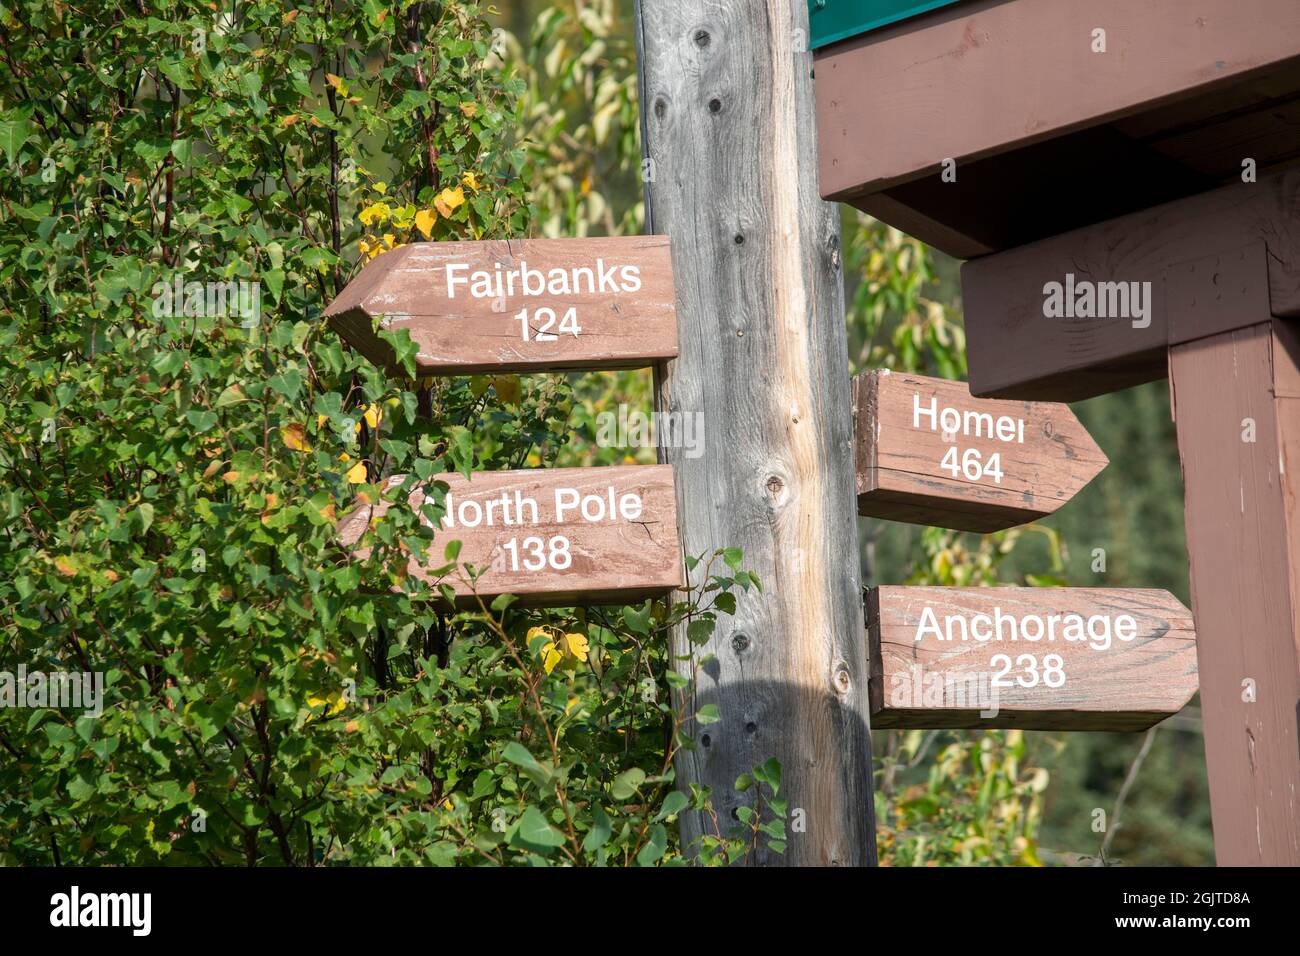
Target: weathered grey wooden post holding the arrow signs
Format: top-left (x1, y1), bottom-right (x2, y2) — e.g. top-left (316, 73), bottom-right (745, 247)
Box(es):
top-left (637, 0), bottom-right (875, 865)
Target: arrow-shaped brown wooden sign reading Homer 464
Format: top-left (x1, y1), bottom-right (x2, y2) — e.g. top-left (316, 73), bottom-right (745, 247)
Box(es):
top-left (853, 369), bottom-right (1106, 532)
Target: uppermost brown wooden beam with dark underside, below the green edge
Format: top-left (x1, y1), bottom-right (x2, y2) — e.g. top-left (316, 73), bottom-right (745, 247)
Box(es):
top-left (816, 0), bottom-right (1300, 258)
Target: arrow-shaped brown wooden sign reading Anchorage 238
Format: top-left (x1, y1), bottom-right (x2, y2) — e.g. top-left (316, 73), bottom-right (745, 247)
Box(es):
top-left (867, 587), bottom-right (1196, 731)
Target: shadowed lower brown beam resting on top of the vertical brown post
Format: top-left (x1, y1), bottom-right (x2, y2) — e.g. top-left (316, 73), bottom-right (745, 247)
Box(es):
top-left (962, 170), bottom-right (1300, 402)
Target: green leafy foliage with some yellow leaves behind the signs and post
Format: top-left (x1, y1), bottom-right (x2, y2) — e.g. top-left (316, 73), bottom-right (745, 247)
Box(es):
top-left (0, 0), bottom-right (1210, 865)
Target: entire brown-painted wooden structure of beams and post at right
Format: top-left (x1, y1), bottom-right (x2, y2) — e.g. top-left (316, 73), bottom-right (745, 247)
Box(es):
top-left (816, 0), bottom-right (1300, 865)
